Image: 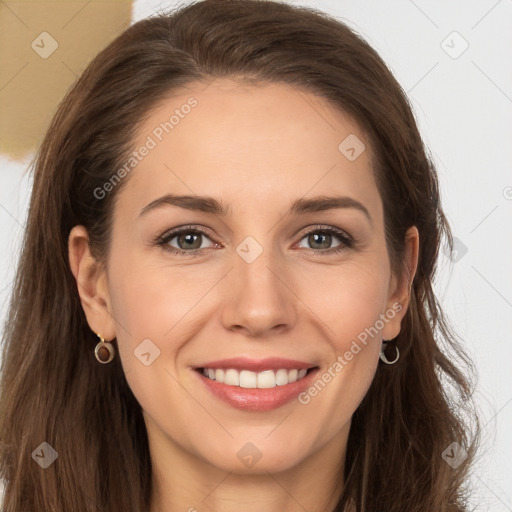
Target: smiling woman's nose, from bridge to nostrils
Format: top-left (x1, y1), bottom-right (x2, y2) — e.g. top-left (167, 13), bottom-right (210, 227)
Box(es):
top-left (222, 237), bottom-right (297, 338)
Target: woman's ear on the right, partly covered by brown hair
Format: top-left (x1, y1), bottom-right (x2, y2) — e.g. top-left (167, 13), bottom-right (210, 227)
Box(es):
top-left (382, 226), bottom-right (420, 340)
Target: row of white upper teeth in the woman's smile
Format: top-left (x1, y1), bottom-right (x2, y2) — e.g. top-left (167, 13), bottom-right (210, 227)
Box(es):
top-left (202, 368), bottom-right (308, 389)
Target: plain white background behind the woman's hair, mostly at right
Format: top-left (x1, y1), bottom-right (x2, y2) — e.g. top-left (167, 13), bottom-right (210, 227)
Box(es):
top-left (0, 0), bottom-right (512, 512)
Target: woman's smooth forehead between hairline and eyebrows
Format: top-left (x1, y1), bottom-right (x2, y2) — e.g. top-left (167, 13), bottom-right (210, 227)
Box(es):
top-left (114, 79), bottom-right (379, 222)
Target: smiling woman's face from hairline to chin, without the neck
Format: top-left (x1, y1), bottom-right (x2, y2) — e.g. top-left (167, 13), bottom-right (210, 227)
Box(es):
top-left (73, 79), bottom-right (416, 472)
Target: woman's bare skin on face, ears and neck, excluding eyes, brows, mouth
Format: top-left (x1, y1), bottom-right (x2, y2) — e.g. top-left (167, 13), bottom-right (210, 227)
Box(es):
top-left (69, 79), bottom-right (419, 512)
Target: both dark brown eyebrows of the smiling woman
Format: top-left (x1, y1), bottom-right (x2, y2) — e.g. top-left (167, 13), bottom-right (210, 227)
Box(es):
top-left (139, 194), bottom-right (372, 223)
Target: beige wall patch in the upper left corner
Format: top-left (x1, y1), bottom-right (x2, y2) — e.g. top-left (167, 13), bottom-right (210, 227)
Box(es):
top-left (0, 0), bottom-right (132, 160)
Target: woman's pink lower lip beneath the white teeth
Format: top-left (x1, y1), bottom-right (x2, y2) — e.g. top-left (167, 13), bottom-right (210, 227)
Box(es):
top-left (194, 368), bottom-right (318, 412)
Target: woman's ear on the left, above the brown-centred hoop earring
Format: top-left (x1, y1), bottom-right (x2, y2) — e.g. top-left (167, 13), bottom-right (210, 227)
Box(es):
top-left (68, 226), bottom-right (116, 341)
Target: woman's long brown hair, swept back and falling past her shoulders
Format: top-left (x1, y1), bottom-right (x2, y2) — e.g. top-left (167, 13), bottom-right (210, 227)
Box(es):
top-left (0, 0), bottom-right (479, 512)
